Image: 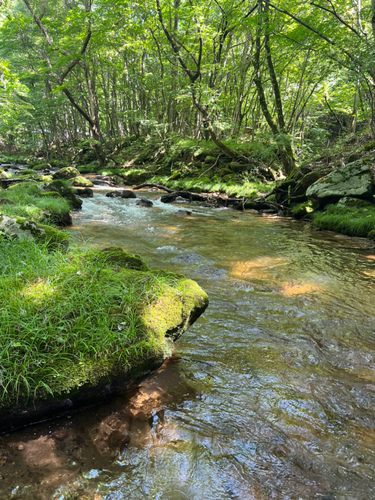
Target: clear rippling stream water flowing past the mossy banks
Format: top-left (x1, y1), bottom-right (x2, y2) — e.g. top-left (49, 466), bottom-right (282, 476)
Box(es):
top-left (0, 192), bottom-right (375, 500)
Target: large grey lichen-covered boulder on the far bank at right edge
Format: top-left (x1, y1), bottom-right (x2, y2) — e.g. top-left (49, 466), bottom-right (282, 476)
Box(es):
top-left (306, 160), bottom-right (375, 207)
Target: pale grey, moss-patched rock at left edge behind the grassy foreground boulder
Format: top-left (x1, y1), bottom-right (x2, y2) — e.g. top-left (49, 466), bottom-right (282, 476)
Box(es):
top-left (0, 213), bottom-right (69, 250)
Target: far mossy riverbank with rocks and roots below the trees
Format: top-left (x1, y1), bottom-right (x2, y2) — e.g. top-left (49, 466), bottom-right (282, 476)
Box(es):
top-left (2, 134), bottom-right (375, 239)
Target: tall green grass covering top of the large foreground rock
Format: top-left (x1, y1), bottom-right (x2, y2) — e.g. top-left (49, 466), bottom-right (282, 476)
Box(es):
top-left (0, 241), bottom-right (176, 408)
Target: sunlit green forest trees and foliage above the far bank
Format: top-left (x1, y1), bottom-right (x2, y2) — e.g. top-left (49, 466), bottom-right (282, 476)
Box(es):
top-left (0, 0), bottom-right (375, 174)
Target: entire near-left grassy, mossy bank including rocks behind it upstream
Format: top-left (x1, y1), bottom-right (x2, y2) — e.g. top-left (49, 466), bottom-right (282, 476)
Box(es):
top-left (0, 177), bottom-right (208, 431)
